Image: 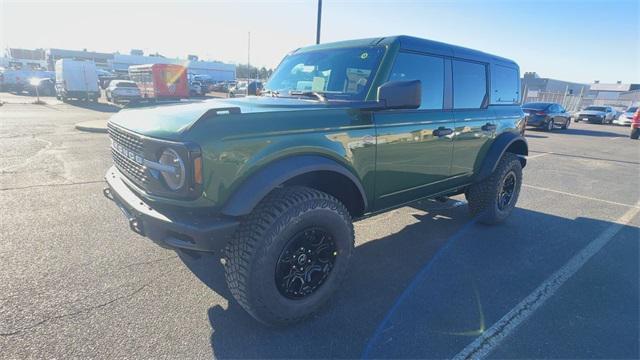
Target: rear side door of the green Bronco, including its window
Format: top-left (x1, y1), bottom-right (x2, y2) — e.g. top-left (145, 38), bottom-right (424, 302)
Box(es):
top-left (451, 59), bottom-right (498, 182)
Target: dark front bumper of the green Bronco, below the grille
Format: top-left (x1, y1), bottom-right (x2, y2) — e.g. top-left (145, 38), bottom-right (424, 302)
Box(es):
top-left (103, 166), bottom-right (239, 252)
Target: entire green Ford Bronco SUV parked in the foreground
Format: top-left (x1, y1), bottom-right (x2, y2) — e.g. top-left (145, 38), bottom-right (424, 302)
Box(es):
top-left (104, 36), bottom-right (528, 324)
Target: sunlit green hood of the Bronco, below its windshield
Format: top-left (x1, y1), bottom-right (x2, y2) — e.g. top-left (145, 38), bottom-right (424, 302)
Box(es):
top-left (109, 96), bottom-right (332, 140)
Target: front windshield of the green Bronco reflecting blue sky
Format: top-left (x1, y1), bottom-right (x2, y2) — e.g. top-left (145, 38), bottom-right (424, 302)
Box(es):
top-left (265, 47), bottom-right (384, 100)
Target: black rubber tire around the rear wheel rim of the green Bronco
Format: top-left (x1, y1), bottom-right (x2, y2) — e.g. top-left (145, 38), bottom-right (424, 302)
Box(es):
top-left (465, 153), bottom-right (522, 225)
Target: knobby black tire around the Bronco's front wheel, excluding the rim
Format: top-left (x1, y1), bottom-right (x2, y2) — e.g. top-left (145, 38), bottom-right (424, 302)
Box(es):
top-left (225, 186), bottom-right (354, 326)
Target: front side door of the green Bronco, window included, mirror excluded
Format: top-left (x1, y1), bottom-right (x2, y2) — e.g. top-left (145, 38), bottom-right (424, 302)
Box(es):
top-left (374, 52), bottom-right (454, 209)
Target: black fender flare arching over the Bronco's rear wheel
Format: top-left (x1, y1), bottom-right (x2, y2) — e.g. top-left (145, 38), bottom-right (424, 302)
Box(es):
top-left (474, 132), bottom-right (529, 182)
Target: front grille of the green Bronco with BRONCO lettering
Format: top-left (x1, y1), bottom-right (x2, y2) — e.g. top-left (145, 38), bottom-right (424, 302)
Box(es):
top-left (107, 124), bottom-right (148, 185)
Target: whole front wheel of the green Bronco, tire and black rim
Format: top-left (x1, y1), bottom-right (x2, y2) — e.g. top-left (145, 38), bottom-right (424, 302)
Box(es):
top-left (225, 186), bottom-right (354, 325)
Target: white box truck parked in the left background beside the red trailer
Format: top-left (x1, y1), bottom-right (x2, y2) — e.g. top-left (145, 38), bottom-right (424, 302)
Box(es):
top-left (56, 59), bottom-right (100, 101)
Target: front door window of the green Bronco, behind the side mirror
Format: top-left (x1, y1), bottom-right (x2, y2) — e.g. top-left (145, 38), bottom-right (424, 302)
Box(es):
top-left (389, 52), bottom-right (444, 109)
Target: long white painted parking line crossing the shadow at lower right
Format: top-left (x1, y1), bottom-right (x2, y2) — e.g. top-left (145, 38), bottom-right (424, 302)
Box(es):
top-left (454, 203), bottom-right (640, 360)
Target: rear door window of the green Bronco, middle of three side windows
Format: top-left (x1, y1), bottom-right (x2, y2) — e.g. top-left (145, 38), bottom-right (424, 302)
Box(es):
top-left (452, 60), bottom-right (487, 109)
